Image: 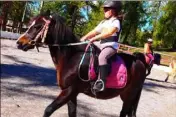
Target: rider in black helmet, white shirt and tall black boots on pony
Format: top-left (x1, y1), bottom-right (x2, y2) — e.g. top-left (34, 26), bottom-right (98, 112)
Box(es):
top-left (81, 1), bottom-right (122, 92)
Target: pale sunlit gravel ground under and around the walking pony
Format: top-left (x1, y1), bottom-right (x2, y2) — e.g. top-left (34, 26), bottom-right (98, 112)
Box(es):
top-left (1, 39), bottom-right (176, 117)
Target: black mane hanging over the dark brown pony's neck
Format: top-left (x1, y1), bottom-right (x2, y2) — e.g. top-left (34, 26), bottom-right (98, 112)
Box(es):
top-left (46, 14), bottom-right (79, 45)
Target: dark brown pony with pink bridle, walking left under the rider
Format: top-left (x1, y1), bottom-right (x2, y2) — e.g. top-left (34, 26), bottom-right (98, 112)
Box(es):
top-left (17, 12), bottom-right (146, 117)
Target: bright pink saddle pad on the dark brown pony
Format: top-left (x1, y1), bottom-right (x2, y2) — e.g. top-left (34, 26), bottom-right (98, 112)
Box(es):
top-left (89, 56), bottom-right (127, 88)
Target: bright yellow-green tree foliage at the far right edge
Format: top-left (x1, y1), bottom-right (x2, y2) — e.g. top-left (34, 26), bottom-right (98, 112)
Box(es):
top-left (153, 1), bottom-right (176, 49)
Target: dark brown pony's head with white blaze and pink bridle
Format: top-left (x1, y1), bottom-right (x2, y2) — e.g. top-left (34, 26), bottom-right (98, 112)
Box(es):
top-left (17, 11), bottom-right (51, 51)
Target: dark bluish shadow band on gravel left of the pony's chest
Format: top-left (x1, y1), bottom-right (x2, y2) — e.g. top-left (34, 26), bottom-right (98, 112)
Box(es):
top-left (1, 62), bottom-right (56, 86)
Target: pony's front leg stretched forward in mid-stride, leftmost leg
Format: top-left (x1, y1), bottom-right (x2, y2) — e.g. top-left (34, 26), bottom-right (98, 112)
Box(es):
top-left (43, 86), bottom-right (77, 117)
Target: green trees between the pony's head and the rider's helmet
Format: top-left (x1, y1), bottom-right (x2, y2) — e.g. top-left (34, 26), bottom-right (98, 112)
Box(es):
top-left (42, 1), bottom-right (103, 37)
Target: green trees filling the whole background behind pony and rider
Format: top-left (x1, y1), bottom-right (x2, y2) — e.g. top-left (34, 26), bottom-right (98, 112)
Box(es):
top-left (0, 0), bottom-right (176, 48)
